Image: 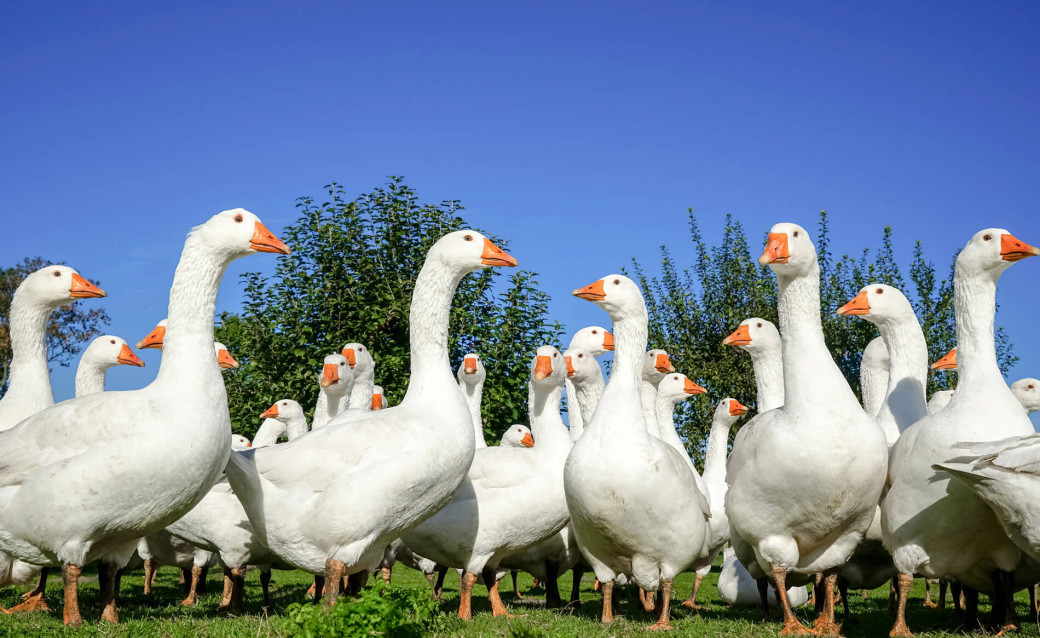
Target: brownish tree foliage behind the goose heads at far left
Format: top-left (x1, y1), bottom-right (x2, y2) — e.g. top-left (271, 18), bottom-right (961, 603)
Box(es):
top-left (0, 257), bottom-right (109, 397)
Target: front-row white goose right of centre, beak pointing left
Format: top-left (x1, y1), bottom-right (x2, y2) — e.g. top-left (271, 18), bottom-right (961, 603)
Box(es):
top-left (565, 275), bottom-right (709, 629)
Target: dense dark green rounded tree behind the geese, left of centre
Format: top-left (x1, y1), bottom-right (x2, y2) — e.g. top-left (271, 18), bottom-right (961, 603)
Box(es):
top-left (216, 177), bottom-right (563, 441)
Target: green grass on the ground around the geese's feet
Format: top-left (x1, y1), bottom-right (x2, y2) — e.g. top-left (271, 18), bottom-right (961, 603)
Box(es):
top-left (0, 566), bottom-right (1040, 638)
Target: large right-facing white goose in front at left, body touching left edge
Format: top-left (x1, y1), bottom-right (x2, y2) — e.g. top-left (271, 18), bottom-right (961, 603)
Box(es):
top-left (0, 208), bottom-right (289, 626)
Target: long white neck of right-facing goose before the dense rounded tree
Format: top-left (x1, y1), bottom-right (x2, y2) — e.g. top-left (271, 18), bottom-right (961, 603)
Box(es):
top-left (401, 257), bottom-right (466, 404)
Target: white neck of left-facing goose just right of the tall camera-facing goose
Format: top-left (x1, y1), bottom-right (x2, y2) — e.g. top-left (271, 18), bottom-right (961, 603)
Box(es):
top-left (878, 310), bottom-right (928, 435)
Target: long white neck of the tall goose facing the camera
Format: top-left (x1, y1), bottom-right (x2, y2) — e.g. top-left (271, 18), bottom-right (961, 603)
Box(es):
top-left (777, 260), bottom-right (859, 414)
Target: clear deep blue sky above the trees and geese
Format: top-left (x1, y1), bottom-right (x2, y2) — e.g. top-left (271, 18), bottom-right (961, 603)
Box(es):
top-left (0, 2), bottom-right (1040, 424)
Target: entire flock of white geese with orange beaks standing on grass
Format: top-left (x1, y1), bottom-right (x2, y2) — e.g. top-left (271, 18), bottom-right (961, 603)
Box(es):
top-left (0, 208), bottom-right (1040, 636)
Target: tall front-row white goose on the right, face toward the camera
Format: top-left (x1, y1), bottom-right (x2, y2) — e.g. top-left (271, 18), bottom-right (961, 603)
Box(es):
top-left (726, 223), bottom-right (888, 635)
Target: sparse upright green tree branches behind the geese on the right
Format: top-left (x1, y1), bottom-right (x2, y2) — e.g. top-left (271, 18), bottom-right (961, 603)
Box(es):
top-left (632, 209), bottom-right (1016, 466)
